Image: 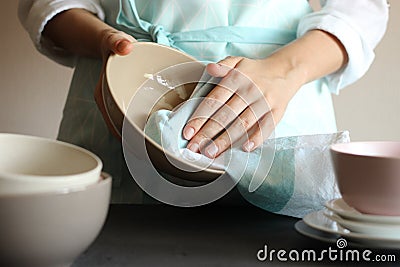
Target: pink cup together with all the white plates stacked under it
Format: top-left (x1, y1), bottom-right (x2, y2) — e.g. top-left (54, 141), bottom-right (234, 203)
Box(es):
top-left (295, 141), bottom-right (400, 249)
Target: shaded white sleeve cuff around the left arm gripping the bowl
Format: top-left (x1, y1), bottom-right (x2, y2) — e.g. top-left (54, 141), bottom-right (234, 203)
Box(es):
top-left (18, 0), bottom-right (104, 66)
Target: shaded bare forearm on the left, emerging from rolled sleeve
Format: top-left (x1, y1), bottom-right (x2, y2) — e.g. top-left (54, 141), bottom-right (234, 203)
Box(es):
top-left (43, 9), bottom-right (115, 58)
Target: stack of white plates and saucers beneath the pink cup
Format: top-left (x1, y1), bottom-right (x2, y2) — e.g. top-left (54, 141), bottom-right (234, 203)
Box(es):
top-left (295, 198), bottom-right (400, 248)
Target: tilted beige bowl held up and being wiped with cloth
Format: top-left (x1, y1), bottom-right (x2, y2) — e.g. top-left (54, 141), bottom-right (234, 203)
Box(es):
top-left (102, 42), bottom-right (223, 181)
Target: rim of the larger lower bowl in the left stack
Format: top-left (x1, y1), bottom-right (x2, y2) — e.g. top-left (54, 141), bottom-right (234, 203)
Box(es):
top-left (0, 172), bottom-right (112, 201)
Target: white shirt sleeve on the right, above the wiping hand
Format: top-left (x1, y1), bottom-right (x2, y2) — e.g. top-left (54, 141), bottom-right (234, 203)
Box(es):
top-left (297, 0), bottom-right (389, 94)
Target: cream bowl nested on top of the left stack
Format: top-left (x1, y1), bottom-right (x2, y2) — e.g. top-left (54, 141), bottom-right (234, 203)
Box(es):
top-left (0, 133), bottom-right (102, 196)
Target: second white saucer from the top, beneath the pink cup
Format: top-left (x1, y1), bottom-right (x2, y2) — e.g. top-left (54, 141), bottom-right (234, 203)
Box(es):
top-left (324, 210), bottom-right (400, 239)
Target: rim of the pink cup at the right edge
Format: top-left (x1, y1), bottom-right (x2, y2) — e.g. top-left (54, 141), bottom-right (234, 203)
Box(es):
top-left (330, 141), bottom-right (400, 160)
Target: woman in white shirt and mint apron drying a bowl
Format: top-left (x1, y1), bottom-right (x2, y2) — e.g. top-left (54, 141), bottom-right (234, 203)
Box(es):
top-left (19, 0), bottom-right (388, 202)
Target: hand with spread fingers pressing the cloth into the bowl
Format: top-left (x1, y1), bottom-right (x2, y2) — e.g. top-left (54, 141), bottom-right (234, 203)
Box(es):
top-left (183, 57), bottom-right (303, 158)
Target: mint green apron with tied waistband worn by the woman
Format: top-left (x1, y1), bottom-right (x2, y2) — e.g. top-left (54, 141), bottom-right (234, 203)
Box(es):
top-left (58, 0), bottom-right (336, 203)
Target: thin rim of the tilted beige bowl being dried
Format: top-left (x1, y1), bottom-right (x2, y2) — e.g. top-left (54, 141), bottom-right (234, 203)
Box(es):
top-left (105, 42), bottom-right (225, 175)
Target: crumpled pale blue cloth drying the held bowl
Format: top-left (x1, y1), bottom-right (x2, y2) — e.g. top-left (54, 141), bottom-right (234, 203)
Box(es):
top-left (145, 74), bottom-right (350, 218)
